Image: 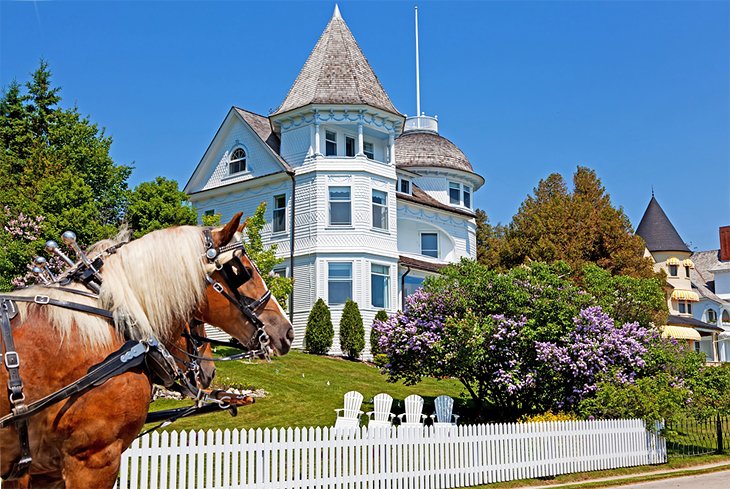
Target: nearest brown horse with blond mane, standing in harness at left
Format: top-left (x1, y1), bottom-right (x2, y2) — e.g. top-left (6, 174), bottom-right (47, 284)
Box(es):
top-left (0, 213), bottom-right (293, 489)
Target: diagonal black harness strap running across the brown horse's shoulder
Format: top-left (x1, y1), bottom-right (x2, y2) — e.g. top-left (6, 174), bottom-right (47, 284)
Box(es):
top-left (0, 341), bottom-right (149, 428)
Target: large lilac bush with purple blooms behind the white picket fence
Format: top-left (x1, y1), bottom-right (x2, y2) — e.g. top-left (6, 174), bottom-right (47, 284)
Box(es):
top-left (373, 263), bottom-right (658, 419)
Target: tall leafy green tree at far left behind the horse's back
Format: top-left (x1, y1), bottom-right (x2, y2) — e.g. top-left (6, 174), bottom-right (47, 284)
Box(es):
top-left (0, 61), bottom-right (131, 288)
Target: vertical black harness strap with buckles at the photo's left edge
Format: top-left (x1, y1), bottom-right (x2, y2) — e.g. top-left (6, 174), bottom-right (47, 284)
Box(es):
top-left (0, 297), bottom-right (33, 479)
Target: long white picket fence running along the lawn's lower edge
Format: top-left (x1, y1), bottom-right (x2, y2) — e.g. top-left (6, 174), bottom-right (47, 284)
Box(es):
top-left (116, 419), bottom-right (667, 489)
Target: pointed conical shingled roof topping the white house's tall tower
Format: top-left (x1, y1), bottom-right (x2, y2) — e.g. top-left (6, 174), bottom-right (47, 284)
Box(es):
top-left (272, 6), bottom-right (401, 115)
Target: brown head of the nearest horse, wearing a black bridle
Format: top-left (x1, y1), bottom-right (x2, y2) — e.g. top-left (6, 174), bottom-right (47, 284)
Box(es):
top-left (200, 212), bottom-right (294, 355)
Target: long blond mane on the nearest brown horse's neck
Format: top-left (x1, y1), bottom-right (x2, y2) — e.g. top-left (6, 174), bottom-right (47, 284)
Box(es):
top-left (16, 226), bottom-right (206, 347)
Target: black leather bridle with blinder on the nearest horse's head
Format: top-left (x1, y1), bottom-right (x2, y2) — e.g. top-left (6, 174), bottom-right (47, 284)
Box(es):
top-left (203, 229), bottom-right (272, 360)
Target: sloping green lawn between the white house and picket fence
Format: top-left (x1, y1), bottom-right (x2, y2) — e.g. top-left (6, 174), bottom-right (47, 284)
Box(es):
top-left (151, 349), bottom-right (463, 430)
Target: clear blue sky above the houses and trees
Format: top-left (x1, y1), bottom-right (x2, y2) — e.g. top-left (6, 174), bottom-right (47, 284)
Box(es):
top-left (0, 1), bottom-right (730, 249)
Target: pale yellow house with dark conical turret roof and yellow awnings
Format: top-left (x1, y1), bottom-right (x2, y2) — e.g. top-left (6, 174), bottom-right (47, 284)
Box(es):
top-left (636, 193), bottom-right (723, 361)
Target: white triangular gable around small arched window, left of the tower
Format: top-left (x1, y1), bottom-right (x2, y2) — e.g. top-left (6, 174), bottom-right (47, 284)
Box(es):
top-left (184, 108), bottom-right (287, 194)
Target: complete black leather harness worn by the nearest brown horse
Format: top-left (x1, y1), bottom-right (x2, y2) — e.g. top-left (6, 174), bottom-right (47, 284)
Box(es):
top-left (0, 229), bottom-right (271, 480)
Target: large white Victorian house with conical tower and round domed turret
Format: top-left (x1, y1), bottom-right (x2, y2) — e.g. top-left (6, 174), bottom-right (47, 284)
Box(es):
top-left (185, 8), bottom-right (484, 354)
